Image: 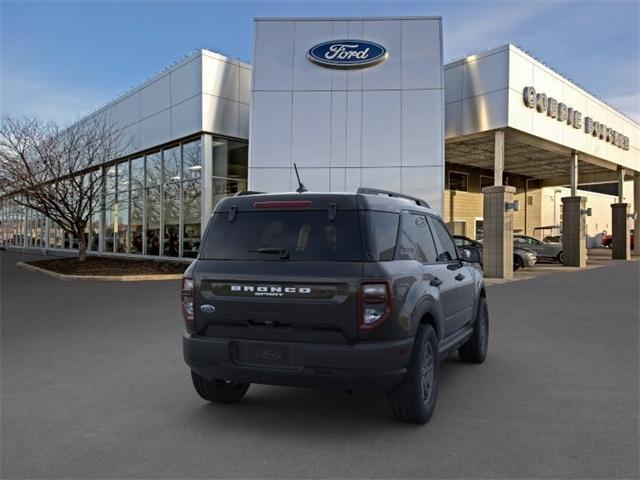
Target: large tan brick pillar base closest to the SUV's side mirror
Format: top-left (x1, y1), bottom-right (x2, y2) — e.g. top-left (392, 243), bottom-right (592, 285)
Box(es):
top-left (482, 185), bottom-right (516, 278)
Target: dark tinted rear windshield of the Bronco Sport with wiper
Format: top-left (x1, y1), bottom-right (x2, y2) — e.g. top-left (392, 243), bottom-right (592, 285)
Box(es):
top-left (201, 210), bottom-right (362, 261)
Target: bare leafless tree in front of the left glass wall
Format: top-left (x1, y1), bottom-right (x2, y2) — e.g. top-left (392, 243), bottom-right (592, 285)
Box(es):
top-left (0, 113), bottom-right (129, 261)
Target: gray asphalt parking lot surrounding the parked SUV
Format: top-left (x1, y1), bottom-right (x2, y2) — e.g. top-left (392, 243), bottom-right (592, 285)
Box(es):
top-left (0, 252), bottom-right (640, 478)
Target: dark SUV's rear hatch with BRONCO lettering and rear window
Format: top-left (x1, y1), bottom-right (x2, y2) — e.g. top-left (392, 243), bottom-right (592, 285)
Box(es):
top-left (193, 195), bottom-right (363, 343)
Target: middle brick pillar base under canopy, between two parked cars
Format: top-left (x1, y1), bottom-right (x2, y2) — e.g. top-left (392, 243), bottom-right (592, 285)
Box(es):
top-left (562, 196), bottom-right (587, 268)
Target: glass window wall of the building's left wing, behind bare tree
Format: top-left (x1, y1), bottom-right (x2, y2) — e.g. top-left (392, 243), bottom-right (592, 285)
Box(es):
top-left (0, 138), bottom-right (242, 258)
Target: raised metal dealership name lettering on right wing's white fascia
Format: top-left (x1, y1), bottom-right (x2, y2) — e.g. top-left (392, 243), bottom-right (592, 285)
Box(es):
top-left (523, 87), bottom-right (629, 150)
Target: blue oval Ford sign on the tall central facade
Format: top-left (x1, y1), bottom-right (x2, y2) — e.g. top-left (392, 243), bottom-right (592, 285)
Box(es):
top-left (307, 40), bottom-right (389, 68)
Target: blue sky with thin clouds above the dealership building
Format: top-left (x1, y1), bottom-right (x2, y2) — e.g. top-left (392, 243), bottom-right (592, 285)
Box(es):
top-left (0, 0), bottom-right (640, 123)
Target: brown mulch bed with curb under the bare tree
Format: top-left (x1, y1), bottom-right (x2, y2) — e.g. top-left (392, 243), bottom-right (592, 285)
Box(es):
top-left (27, 257), bottom-right (189, 276)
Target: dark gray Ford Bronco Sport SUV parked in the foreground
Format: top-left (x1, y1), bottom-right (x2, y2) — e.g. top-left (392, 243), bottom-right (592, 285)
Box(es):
top-left (182, 189), bottom-right (489, 423)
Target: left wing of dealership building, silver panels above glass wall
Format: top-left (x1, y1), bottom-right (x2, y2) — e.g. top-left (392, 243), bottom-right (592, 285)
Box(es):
top-left (0, 50), bottom-right (251, 259)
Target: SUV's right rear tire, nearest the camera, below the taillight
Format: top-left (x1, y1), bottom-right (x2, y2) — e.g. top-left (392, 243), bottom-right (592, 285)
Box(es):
top-left (387, 325), bottom-right (439, 423)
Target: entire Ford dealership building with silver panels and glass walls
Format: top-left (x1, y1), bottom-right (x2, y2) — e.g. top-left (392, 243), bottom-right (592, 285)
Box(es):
top-left (0, 17), bottom-right (640, 277)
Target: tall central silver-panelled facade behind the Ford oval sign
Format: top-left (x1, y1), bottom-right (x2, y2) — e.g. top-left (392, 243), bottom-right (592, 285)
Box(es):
top-left (249, 17), bottom-right (444, 211)
